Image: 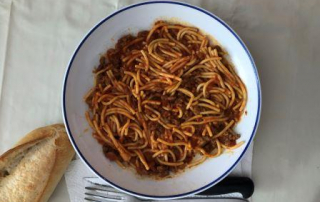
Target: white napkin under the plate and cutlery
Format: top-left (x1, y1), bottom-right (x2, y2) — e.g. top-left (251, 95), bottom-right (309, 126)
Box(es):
top-left (65, 144), bottom-right (253, 202)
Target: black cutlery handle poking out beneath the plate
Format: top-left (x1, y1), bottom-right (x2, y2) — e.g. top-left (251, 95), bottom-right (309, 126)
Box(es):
top-left (198, 177), bottom-right (254, 199)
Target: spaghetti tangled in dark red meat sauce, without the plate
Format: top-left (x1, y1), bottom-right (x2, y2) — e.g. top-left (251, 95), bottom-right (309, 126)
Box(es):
top-left (85, 21), bottom-right (247, 177)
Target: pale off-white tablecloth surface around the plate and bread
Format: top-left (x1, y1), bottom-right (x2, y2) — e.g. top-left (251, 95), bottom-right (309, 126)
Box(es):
top-left (0, 0), bottom-right (320, 202)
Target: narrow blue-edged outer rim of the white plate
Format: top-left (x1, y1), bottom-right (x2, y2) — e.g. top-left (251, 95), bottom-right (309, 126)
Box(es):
top-left (62, 1), bottom-right (261, 199)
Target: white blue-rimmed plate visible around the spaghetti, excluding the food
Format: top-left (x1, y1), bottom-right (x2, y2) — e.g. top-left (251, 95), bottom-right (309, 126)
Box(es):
top-left (62, 1), bottom-right (261, 199)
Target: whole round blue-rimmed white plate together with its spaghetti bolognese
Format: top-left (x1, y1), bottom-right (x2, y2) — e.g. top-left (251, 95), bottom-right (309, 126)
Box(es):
top-left (62, 1), bottom-right (261, 199)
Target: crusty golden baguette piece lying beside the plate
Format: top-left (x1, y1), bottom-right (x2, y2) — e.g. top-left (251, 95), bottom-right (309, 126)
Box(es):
top-left (0, 124), bottom-right (74, 202)
